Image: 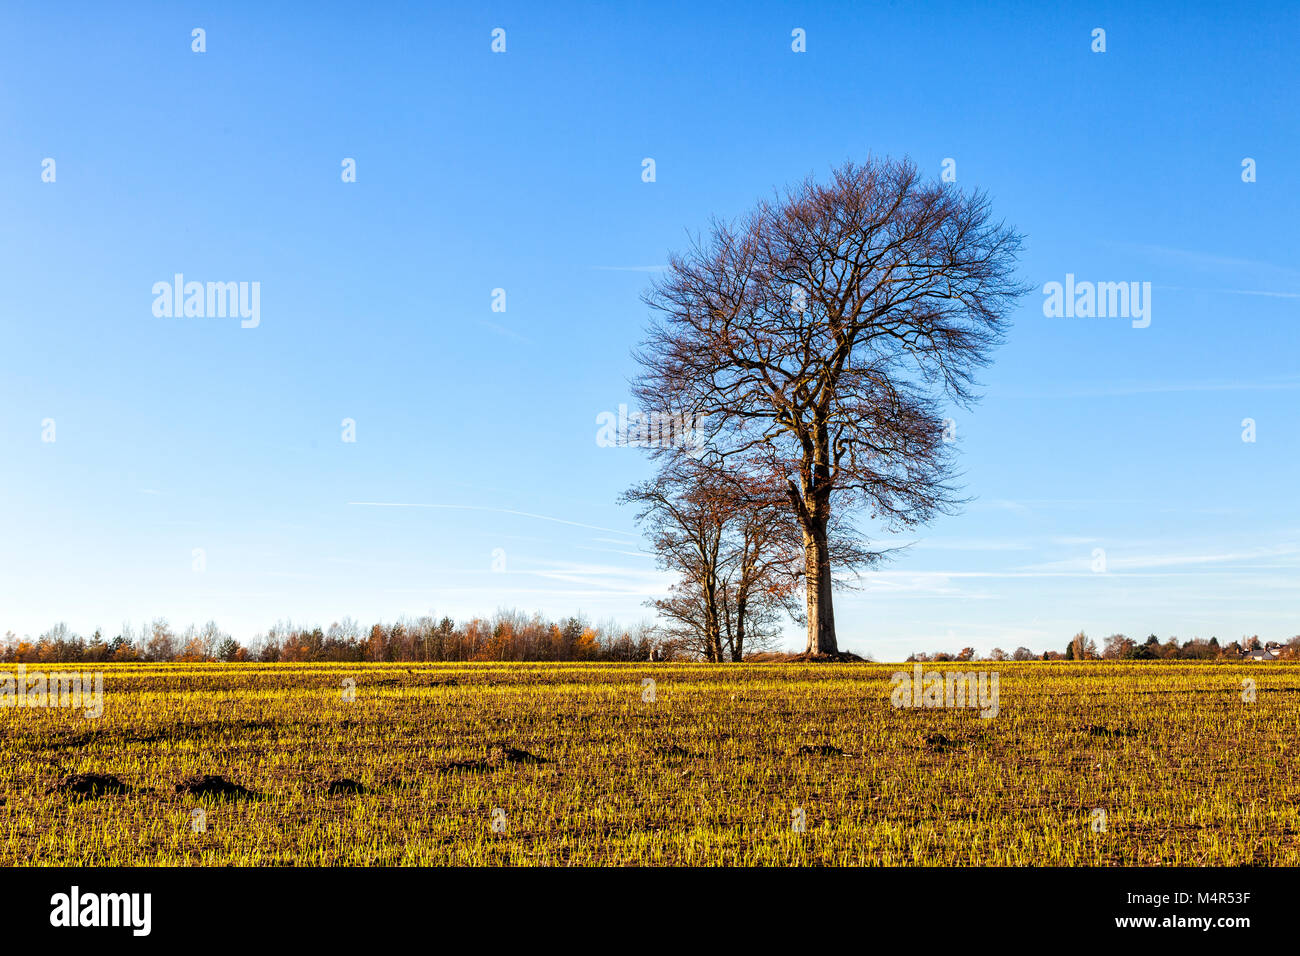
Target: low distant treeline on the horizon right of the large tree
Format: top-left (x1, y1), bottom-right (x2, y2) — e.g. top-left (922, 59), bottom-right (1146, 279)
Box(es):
top-left (907, 631), bottom-right (1300, 662)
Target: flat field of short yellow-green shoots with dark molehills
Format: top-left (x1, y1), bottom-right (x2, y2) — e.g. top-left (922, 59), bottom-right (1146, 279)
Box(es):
top-left (0, 662), bottom-right (1300, 866)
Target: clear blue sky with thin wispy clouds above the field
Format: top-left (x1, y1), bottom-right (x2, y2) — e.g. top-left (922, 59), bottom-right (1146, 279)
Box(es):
top-left (0, 3), bottom-right (1300, 659)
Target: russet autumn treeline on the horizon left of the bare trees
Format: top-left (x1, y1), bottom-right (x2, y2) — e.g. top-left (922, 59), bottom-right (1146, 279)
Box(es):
top-left (0, 611), bottom-right (670, 663)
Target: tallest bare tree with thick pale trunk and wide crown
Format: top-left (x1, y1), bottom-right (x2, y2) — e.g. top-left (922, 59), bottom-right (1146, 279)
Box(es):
top-left (634, 160), bottom-right (1028, 654)
